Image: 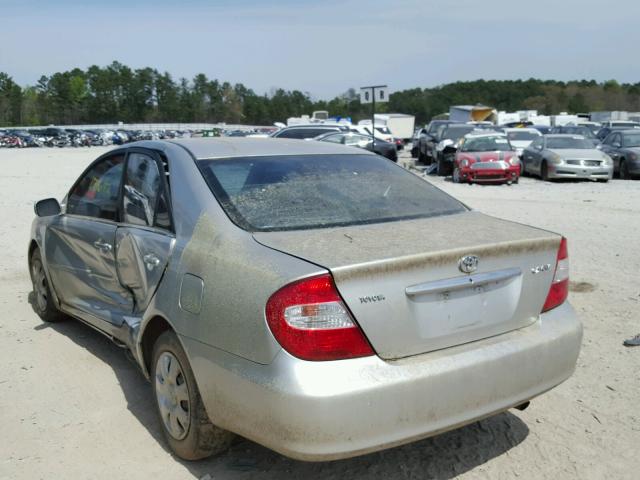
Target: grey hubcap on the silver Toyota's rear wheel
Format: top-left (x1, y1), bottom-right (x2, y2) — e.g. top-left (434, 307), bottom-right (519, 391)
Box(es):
top-left (156, 352), bottom-right (191, 440)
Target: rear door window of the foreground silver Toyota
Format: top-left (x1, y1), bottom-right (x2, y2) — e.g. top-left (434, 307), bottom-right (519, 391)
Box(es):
top-left (122, 152), bottom-right (171, 229)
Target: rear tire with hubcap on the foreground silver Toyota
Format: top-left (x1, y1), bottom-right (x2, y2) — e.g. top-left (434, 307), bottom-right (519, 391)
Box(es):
top-left (150, 330), bottom-right (234, 460)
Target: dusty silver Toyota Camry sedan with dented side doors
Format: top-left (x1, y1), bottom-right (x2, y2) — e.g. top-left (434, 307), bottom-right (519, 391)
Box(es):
top-left (29, 138), bottom-right (582, 460)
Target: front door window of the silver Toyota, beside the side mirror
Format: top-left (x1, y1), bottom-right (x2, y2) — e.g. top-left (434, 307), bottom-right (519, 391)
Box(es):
top-left (67, 154), bottom-right (124, 222)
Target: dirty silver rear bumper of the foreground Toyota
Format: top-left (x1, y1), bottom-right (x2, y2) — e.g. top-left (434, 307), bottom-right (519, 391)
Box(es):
top-left (181, 302), bottom-right (582, 461)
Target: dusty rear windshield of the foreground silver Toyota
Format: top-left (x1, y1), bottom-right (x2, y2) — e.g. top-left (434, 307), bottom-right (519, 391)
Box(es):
top-left (198, 154), bottom-right (466, 231)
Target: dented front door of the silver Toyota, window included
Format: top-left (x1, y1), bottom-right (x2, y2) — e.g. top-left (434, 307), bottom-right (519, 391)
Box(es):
top-left (45, 151), bottom-right (133, 327)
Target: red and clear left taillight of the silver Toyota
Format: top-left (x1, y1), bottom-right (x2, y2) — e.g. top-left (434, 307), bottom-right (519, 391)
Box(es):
top-left (266, 274), bottom-right (373, 360)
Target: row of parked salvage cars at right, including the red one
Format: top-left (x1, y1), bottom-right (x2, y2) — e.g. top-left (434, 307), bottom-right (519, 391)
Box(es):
top-left (411, 120), bottom-right (640, 184)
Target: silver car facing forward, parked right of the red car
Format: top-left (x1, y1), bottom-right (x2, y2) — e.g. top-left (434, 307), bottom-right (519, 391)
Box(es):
top-left (520, 134), bottom-right (613, 182)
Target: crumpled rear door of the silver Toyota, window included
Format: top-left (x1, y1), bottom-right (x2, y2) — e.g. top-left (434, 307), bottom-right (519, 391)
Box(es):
top-left (115, 149), bottom-right (175, 315)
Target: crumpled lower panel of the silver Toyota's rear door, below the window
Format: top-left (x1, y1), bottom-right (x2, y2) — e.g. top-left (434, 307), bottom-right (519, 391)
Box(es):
top-left (116, 227), bottom-right (175, 314)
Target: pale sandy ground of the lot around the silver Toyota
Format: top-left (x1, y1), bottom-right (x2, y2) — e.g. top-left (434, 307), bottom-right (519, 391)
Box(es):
top-left (0, 148), bottom-right (640, 480)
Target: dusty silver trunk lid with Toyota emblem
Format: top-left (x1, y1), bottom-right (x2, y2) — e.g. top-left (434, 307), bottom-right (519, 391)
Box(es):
top-left (254, 212), bottom-right (561, 359)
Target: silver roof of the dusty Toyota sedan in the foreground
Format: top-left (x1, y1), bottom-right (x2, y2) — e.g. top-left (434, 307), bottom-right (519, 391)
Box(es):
top-left (161, 137), bottom-right (375, 160)
